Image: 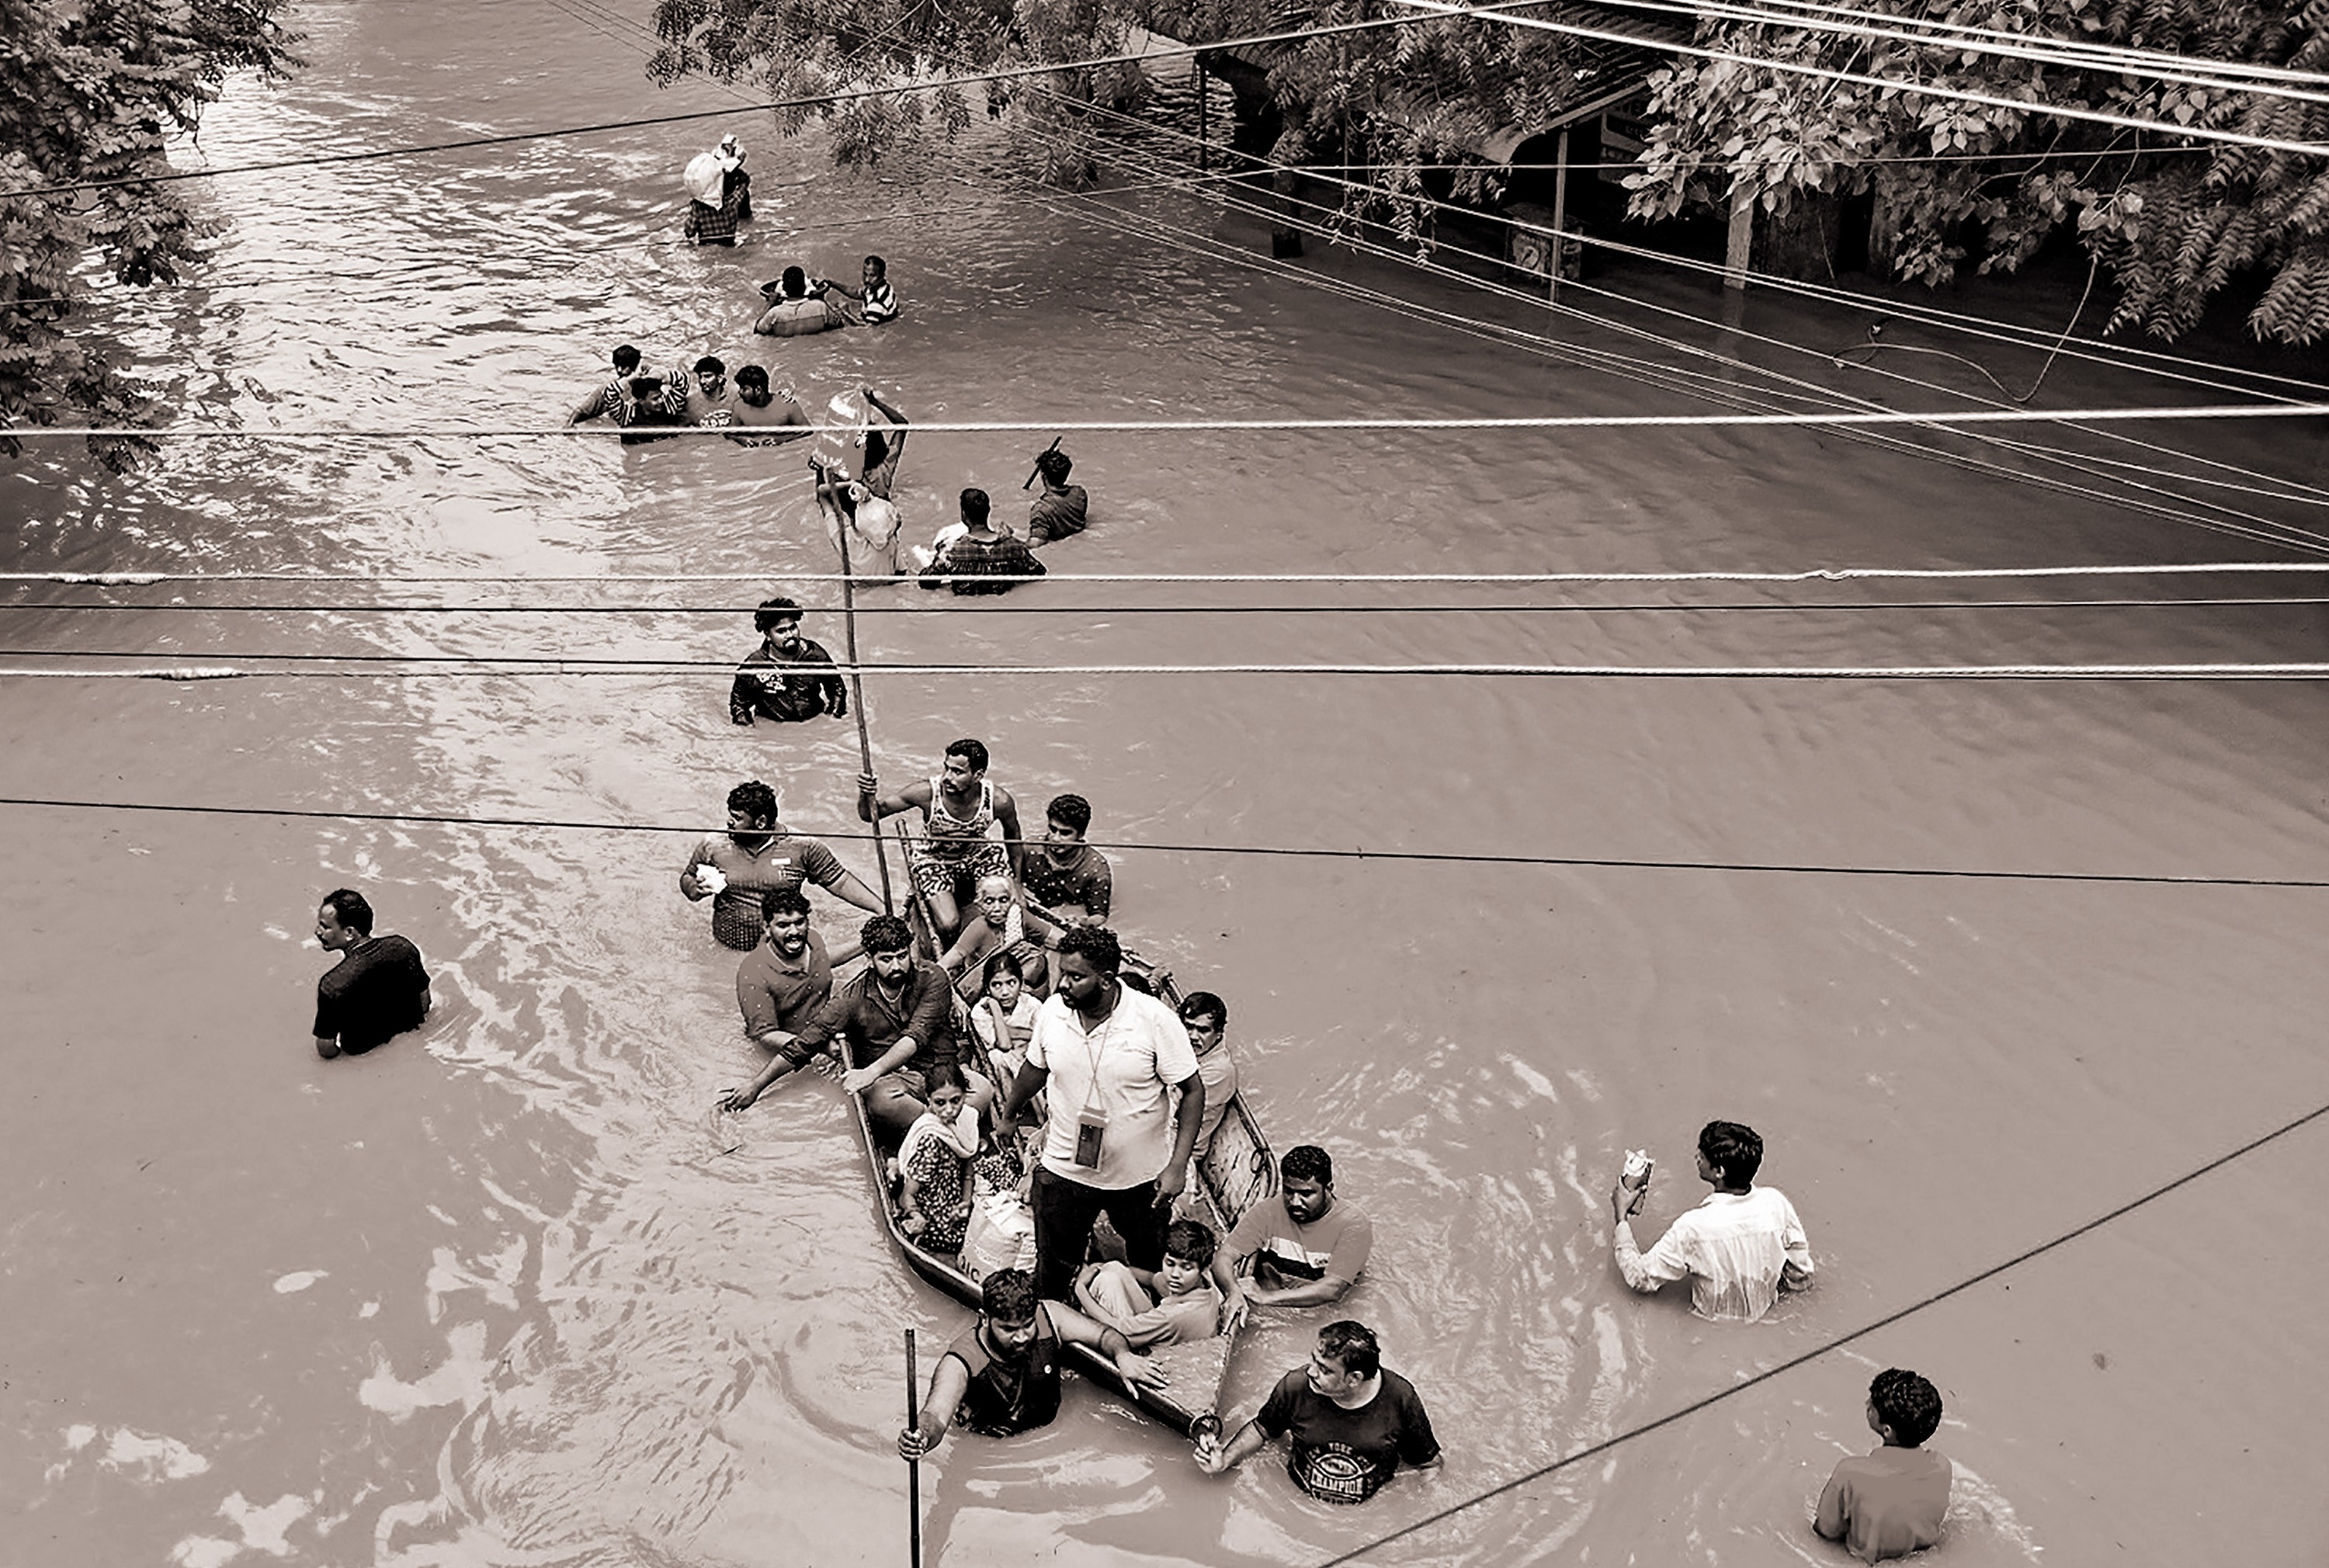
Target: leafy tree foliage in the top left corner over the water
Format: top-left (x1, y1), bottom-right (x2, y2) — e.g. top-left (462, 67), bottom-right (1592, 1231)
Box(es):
top-left (0, 0), bottom-right (296, 466)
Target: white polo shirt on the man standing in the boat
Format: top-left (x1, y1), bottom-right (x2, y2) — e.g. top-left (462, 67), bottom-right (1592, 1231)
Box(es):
top-left (1027, 986), bottom-right (1197, 1191)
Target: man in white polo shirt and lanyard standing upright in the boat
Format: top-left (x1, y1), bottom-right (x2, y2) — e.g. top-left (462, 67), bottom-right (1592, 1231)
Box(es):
top-left (1004, 925), bottom-right (1204, 1300)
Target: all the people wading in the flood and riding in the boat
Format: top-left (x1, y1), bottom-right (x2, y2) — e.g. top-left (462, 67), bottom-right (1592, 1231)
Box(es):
top-left (314, 142), bottom-right (1952, 1561)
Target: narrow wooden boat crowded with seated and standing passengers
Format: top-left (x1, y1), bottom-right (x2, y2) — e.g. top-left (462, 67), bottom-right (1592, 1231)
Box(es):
top-left (843, 830), bottom-right (1279, 1435)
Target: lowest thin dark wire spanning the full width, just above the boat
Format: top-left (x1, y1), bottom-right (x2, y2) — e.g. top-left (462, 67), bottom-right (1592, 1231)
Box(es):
top-left (0, 795), bottom-right (2329, 890)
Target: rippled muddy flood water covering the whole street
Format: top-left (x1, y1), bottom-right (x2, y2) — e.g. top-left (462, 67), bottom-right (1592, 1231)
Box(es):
top-left (0, 0), bottom-right (2329, 1568)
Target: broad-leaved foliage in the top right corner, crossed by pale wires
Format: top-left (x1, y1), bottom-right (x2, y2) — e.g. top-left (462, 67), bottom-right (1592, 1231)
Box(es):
top-left (1628, 0), bottom-right (2329, 342)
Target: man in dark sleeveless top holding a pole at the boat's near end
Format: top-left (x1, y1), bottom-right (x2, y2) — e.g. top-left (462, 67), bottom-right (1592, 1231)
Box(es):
top-left (897, 1268), bottom-right (1164, 1463)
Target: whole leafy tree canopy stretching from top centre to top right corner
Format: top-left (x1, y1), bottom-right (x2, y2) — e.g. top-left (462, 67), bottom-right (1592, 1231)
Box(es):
top-left (652, 0), bottom-right (2329, 342)
